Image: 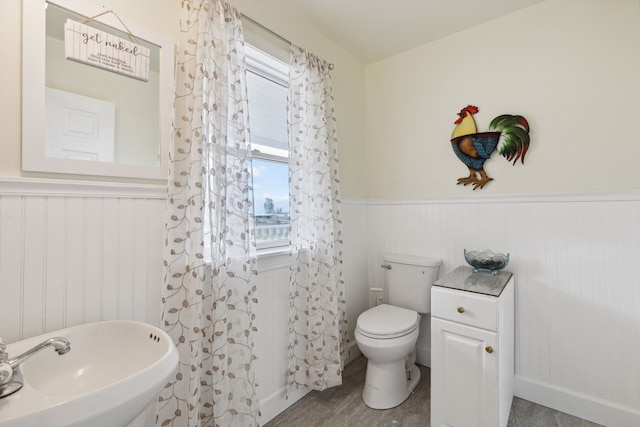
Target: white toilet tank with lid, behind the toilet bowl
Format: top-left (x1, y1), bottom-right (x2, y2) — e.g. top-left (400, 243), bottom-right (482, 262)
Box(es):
top-left (382, 254), bottom-right (442, 314)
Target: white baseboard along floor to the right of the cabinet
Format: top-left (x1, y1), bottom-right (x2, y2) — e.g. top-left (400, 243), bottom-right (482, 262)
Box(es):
top-left (514, 375), bottom-right (640, 427)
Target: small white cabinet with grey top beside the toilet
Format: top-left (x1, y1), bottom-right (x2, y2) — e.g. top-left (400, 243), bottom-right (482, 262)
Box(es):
top-left (431, 266), bottom-right (514, 427)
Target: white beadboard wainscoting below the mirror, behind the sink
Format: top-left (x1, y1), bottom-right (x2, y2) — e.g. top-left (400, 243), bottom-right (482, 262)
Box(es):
top-left (0, 178), bottom-right (166, 427)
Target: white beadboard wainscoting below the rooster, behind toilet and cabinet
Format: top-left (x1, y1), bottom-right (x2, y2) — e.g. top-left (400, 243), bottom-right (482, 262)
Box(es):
top-left (361, 191), bottom-right (640, 427)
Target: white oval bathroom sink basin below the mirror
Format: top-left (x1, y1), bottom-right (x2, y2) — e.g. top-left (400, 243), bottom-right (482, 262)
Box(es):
top-left (0, 320), bottom-right (178, 427)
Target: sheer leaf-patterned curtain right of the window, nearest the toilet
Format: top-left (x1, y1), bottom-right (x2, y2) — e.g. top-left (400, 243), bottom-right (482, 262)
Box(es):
top-left (288, 45), bottom-right (347, 390)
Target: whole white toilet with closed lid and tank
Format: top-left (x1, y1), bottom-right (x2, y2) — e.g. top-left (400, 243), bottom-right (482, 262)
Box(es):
top-left (355, 255), bottom-right (441, 409)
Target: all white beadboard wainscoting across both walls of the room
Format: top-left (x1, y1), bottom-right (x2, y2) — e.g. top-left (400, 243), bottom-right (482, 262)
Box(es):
top-left (0, 178), bottom-right (640, 427)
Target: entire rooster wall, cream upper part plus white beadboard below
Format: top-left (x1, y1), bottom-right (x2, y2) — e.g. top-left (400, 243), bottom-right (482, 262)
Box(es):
top-left (354, 0), bottom-right (640, 427)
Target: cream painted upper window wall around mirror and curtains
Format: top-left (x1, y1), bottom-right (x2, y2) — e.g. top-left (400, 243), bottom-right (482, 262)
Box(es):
top-left (0, 0), bottom-right (366, 197)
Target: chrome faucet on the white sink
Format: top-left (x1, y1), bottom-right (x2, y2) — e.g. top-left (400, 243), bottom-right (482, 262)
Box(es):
top-left (0, 337), bottom-right (71, 399)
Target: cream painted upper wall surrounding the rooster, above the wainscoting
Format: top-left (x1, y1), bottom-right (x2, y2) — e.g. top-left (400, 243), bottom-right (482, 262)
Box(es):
top-left (366, 0), bottom-right (640, 198)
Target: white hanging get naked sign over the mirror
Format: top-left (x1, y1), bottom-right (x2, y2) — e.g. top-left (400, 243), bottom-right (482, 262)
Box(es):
top-left (64, 19), bottom-right (150, 82)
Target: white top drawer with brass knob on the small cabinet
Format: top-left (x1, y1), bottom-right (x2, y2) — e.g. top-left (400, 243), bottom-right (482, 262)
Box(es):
top-left (431, 286), bottom-right (498, 331)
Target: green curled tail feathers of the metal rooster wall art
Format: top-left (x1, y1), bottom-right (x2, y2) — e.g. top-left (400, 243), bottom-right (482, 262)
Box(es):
top-left (489, 114), bottom-right (531, 165)
